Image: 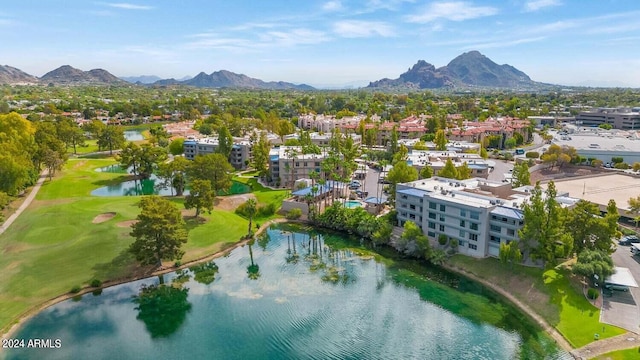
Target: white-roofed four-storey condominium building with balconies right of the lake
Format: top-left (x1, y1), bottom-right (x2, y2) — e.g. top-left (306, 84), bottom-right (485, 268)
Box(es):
top-left (396, 177), bottom-right (532, 258)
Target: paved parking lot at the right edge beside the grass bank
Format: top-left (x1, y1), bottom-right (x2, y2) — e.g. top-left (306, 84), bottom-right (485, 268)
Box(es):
top-left (600, 240), bottom-right (640, 334)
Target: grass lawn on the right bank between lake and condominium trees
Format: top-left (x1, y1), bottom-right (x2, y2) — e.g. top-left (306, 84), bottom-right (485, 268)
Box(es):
top-left (450, 255), bottom-right (625, 348)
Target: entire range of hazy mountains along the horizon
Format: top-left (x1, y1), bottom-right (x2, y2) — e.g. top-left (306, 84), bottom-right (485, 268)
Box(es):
top-left (0, 51), bottom-right (548, 90)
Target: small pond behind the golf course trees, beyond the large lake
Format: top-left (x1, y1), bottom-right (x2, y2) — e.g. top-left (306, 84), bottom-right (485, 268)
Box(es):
top-left (91, 164), bottom-right (251, 196)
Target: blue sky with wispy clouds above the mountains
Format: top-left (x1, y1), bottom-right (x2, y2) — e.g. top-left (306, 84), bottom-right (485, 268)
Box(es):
top-left (0, 0), bottom-right (640, 87)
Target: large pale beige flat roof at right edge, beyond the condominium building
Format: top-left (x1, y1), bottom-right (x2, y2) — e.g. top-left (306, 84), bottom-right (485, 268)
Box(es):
top-left (541, 173), bottom-right (640, 210)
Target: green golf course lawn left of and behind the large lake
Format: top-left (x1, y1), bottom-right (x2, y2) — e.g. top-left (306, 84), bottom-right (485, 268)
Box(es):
top-left (0, 159), bottom-right (266, 332)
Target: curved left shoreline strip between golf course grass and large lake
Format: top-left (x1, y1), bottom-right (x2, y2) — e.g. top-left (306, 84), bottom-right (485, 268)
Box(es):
top-left (0, 218), bottom-right (289, 344)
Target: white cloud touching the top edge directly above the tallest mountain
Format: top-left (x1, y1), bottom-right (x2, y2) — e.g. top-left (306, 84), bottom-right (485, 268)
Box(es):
top-left (407, 1), bottom-right (498, 23)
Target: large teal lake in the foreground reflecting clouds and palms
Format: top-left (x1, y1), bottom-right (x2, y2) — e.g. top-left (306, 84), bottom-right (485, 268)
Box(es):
top-left (6, 227), bottom-right (556, 360)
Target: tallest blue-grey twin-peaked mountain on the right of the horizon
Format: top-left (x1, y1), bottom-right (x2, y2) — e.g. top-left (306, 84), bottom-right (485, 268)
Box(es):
top-left (367, 51), bottom-right (537, 89)
